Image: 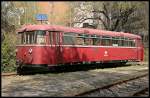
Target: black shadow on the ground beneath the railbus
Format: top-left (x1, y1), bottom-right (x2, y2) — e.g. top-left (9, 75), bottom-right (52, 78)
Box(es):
top-left (20, 63), bottom-right (131, 75)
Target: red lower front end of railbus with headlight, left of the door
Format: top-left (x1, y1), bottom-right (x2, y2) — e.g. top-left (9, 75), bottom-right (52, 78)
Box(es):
top-left (17, 46), bottom-right (56, 64)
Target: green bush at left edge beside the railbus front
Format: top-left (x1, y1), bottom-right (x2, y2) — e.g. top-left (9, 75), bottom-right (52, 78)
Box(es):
top-left (1, 34), bottom-right (16, 72)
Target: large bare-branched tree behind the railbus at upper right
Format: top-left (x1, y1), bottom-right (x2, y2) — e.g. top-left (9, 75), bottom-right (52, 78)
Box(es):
top-left (73, 2), bottom-right (146, 33)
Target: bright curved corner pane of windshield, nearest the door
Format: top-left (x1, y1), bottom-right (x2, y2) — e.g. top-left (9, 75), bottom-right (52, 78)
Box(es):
top-left (36, 31), bottom-right (46, 44)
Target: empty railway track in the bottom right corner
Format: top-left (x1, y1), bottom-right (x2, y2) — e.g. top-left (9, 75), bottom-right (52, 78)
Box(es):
top-left (75, 74), bottom-right (148, 97)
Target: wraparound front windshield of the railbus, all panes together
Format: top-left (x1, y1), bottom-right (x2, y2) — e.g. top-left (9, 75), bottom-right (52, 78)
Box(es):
top-left (19, 31), bottom-right (46, 44)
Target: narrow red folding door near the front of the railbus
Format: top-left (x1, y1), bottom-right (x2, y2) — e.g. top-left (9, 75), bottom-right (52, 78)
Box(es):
top-left (53, 31), bottom-right (63, 64)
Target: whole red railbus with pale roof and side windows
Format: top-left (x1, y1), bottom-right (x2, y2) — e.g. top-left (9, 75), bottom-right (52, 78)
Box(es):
top-left (16, 25), bottom-right (144, 72)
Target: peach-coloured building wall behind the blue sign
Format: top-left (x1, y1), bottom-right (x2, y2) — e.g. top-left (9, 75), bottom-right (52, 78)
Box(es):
top-left (37, 2), bottom-right (69, 25)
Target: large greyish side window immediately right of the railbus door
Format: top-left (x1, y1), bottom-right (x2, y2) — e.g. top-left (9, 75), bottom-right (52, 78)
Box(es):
top-left (63, 33), bottom-right (75, 45)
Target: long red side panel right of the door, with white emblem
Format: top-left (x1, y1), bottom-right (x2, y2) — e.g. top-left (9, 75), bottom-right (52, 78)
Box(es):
top-left (63, 47), bottom-right (137, 62)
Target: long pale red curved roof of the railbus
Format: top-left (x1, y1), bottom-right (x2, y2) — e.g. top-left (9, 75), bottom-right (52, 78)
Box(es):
top-left (18, 25), bottom-right (141, 39)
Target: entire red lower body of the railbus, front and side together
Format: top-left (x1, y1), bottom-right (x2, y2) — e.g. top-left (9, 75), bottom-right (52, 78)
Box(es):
top-left (17, 45), bottom-right (142, 65)
